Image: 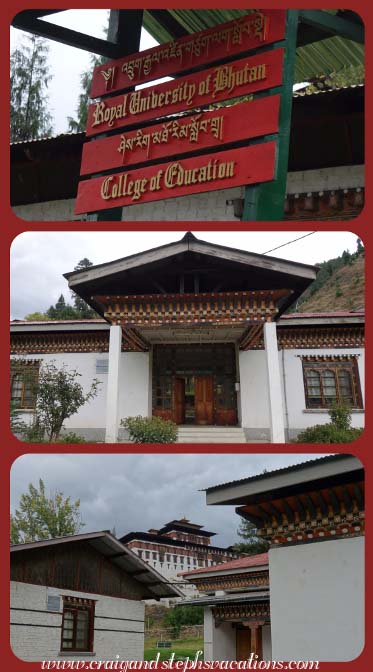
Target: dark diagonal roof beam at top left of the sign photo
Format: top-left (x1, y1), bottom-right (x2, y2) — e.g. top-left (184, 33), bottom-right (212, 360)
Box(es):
top-left (12, 10), bottom-right (121, 58)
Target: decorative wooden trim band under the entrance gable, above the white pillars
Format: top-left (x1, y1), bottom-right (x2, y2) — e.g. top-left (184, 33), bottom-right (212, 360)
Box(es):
top-left (94, 289), bottom-right (292, 326)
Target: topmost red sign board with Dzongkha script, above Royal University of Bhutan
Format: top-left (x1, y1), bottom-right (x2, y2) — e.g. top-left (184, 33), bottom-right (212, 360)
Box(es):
top-left (90, 9), bottom-right (285, 98)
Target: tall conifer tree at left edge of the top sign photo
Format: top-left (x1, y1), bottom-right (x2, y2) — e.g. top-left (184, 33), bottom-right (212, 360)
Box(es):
top-left (10, 35), bottom-right (52, 142)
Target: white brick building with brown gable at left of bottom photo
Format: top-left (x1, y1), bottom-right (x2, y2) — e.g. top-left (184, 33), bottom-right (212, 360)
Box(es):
top-left (10, 531), bottom-right (182, 666)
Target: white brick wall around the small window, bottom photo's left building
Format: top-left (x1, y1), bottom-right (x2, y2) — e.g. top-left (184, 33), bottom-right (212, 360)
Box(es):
top-left (10, 581), bottom-right (145, 661)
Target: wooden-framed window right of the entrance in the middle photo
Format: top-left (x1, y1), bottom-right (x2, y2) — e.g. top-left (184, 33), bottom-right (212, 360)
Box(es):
top-left (302, 356), bottom-right (362, 408)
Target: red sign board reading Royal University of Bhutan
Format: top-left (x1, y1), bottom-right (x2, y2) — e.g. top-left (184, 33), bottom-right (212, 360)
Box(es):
top-left (86, 49), bottom-right (283, 136)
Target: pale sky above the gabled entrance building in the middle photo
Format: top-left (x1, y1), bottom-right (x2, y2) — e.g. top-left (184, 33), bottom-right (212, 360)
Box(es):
top-left (10, 231), bottom-right (357, 319)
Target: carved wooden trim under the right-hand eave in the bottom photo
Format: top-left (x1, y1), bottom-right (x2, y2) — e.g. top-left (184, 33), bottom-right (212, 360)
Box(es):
top-left (236, 481), bottom-right (365, 546)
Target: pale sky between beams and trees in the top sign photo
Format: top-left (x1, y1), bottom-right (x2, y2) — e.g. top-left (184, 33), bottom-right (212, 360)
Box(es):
top-left (10, 9), bottom-right (157, 135)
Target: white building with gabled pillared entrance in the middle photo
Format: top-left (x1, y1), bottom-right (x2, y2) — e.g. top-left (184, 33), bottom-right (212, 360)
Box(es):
top-left (11, 233), bottom-right (364, 443)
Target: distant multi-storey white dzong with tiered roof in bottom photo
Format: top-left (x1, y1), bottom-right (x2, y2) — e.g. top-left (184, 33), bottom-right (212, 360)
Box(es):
top-left (120, 518), bottom-right (240, 594)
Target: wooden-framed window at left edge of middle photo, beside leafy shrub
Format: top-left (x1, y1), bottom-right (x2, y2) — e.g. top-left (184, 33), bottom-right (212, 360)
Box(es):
top-left (10, 359), bottom-right (40, 409)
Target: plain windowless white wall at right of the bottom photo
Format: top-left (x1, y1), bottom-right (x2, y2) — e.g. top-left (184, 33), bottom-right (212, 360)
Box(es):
top-left (269, 537), bottom-right (365, 662)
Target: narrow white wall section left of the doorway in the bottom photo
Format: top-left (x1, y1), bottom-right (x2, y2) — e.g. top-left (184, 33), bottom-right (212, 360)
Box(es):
top-left (204, 607), bottom-right (236, 661)
